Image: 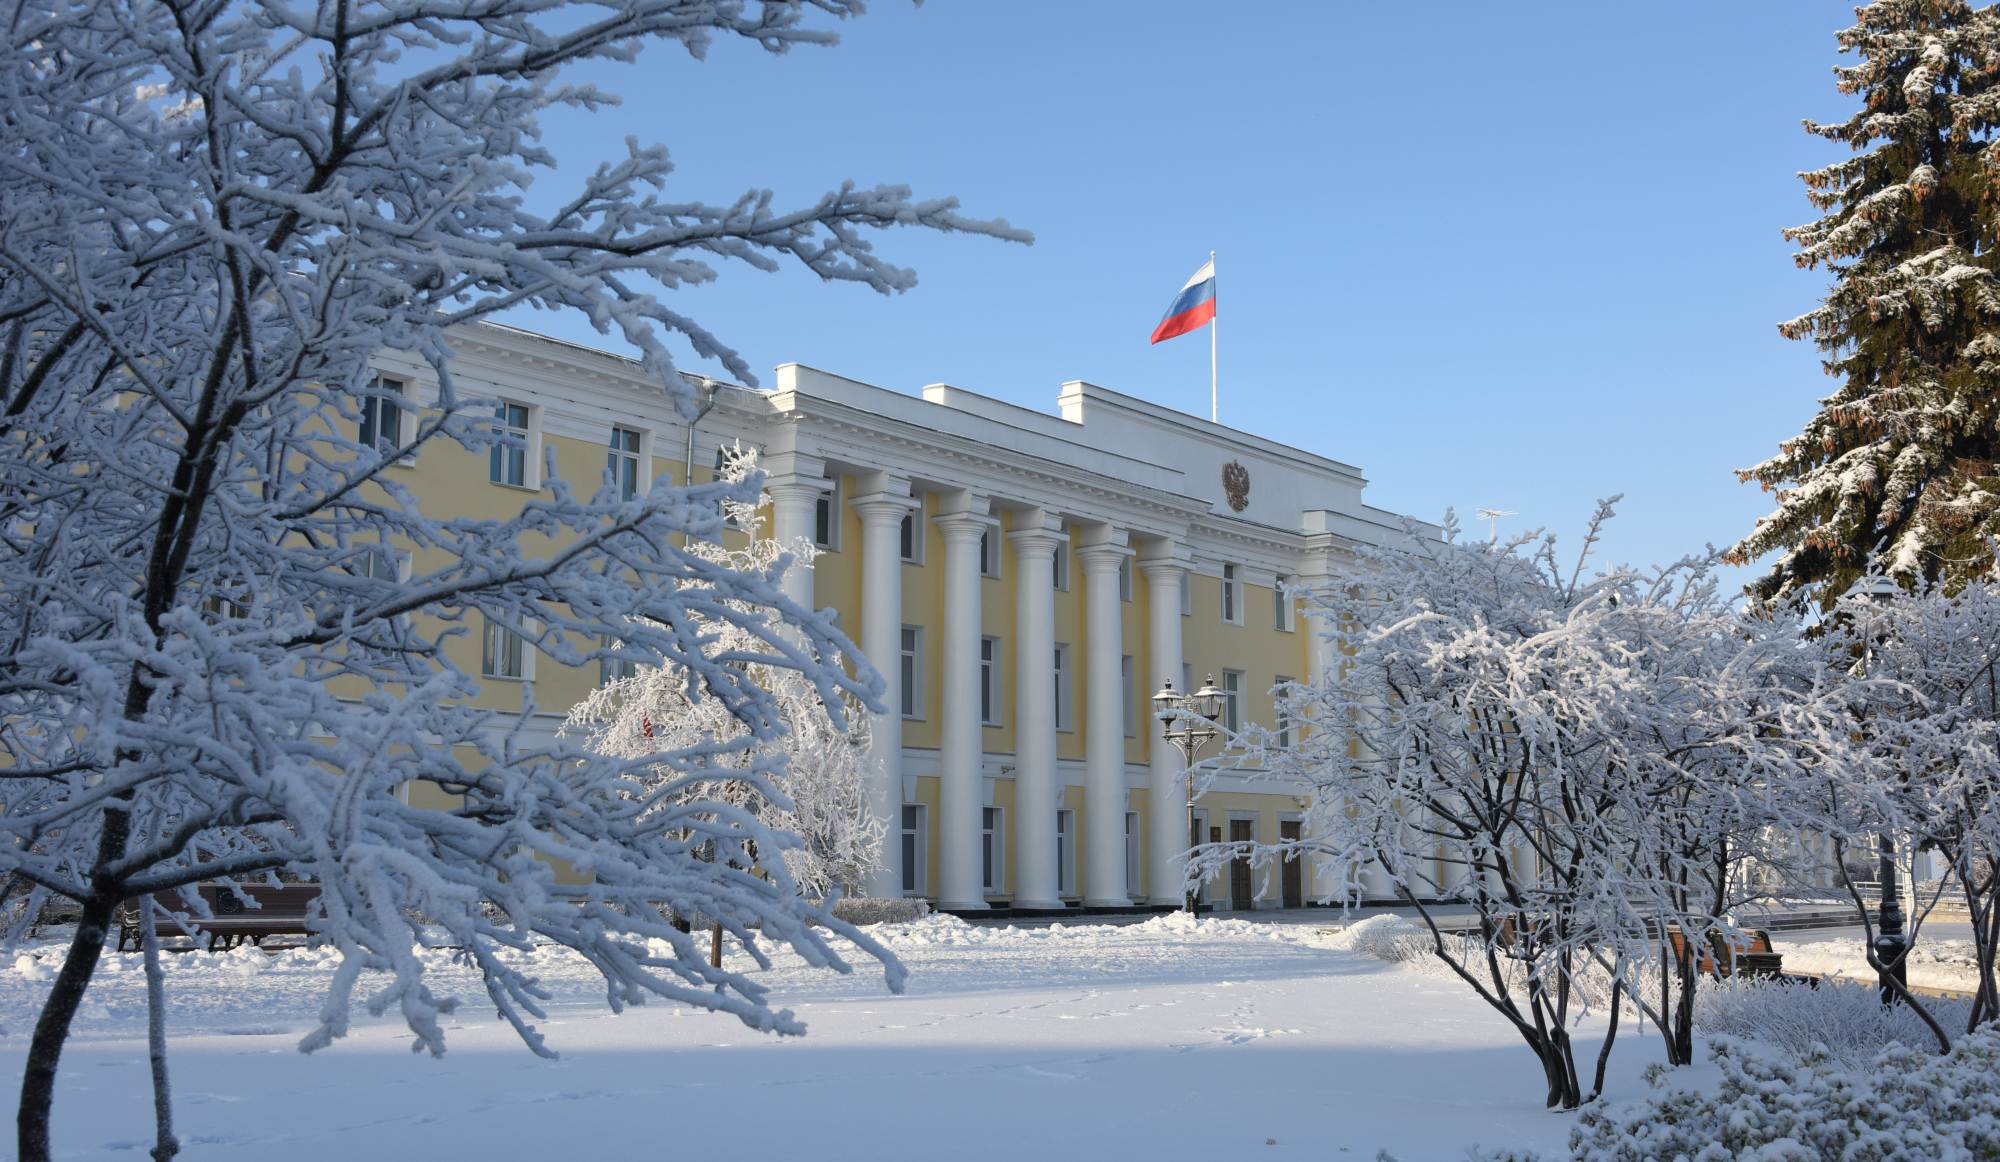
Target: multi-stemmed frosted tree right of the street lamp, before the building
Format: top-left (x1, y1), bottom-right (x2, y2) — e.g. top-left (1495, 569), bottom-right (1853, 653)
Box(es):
top-left (1204, 502), bottom-right (1846, 1108)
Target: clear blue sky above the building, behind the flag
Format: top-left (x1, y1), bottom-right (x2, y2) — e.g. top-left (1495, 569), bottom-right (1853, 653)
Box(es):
top-left (516, 0), bottom-right (1852, 588)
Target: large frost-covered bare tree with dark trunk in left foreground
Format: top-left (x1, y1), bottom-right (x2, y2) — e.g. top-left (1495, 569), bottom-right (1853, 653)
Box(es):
top-left (0, 0), bottom-right (1026, 1160)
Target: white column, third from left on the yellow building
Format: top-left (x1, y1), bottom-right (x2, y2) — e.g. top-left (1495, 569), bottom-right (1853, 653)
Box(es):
top-left (934, 496), bottom-right (994, 910)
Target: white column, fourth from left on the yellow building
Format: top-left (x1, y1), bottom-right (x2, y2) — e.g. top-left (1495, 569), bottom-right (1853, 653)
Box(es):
top-left (1008, 510), bottom-right (1064, 908)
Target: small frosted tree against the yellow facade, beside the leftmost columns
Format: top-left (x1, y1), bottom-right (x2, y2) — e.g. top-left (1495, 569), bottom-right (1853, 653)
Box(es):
top-left (564, 450), bottom-right (888, 900)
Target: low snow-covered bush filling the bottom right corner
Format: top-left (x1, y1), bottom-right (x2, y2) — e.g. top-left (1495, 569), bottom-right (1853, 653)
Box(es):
top-left (1474, 1028), bottom-right (2000, 1162)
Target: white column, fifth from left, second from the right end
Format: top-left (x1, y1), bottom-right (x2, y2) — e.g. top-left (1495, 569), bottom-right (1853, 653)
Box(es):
top-left (1076, 532), bottom-right (1132, 908)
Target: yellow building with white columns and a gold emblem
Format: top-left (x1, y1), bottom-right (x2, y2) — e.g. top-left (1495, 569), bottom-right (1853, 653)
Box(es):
top-left (370, 326), bottom-right (1432, 912)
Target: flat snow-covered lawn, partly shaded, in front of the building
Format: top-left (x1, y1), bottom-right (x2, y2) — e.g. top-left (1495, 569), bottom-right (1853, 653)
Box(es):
top-left (0, 916), bottom-right (1658, 1162)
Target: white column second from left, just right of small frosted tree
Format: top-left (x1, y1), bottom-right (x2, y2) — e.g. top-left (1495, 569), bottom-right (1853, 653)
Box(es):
top-left (854, 482), bottom-right (918, 898)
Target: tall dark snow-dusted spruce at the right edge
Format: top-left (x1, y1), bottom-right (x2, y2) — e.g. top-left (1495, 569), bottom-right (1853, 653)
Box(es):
top-left (1730, 0), bottom-right (2000, 606)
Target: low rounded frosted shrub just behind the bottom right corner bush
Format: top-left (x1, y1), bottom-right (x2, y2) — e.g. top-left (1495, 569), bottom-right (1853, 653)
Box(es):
top-left (1694, 976), bottom-right (1970, 1066)
